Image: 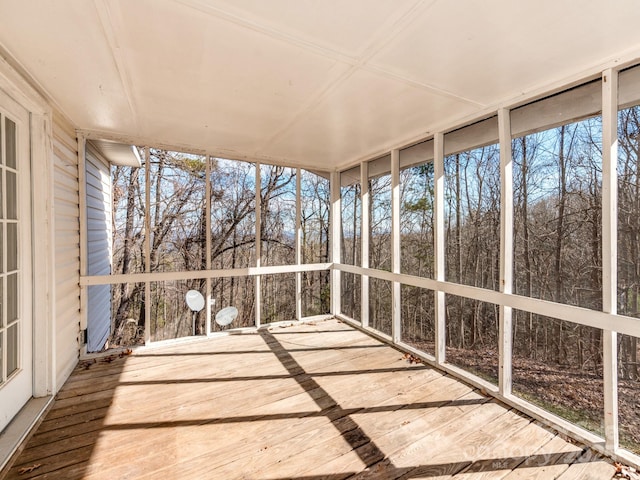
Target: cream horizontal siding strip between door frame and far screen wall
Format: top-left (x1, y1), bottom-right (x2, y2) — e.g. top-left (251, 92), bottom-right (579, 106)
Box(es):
top-left (53, 111), bottom-right (80, 390)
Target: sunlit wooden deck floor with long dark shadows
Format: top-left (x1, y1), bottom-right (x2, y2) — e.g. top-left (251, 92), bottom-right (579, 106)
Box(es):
top-left (2, 320), bottom-right (614, 480)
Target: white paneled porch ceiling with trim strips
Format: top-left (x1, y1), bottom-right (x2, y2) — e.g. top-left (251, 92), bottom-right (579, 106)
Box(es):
top-left (0, 0), bottom-right (640, 169)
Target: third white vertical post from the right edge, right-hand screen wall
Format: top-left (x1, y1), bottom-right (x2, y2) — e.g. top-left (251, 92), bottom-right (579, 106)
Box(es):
top-left (433, 133), bottom-right (446, 364)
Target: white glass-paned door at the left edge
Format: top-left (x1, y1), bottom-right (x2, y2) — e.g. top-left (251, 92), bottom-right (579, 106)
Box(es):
top-left (0, 91), bottom-right (33, 431)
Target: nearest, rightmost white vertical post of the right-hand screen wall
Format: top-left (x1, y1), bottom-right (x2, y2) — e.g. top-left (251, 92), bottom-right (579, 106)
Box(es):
top-left (602, 69), bottom-right (618, 452)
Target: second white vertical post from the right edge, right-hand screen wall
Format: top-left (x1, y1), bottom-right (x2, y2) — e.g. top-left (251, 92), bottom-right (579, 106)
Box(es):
top-left (498, 109), bottom-right (513, 396)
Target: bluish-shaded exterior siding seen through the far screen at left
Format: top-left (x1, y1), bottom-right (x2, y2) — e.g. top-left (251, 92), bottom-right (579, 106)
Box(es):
top-left (85, 143), bottom-right (111, 352)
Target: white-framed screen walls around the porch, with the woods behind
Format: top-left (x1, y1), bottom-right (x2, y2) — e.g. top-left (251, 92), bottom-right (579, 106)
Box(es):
top-left (71, 67), bottom-right (640, 472)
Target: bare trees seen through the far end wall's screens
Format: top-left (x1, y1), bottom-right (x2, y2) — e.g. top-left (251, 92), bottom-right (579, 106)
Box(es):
top-left (111, 155), bottom-right (329, 345)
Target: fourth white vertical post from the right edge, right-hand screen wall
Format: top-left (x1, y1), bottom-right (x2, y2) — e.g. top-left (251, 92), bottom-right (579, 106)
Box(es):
top-left (391, 149), bottom-right (402, 343)
